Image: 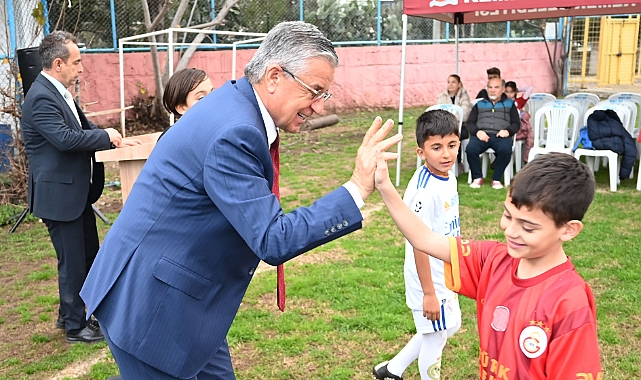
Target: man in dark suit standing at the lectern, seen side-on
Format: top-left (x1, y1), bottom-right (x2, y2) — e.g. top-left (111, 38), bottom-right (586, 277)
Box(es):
top-left (21, 31), bottom-right (139, 343)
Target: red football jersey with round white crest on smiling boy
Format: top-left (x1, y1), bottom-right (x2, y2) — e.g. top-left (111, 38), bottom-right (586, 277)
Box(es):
top-left (445, 237), bottom-right (603, 380)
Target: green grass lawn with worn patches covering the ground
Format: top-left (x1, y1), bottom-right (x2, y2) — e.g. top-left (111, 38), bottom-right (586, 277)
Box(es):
top-left (0, 109), bottom-right (641, 380)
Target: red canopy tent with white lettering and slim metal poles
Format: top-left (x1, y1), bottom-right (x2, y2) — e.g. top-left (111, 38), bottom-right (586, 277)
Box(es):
top-left (396, 0), bottom-right (641, 186)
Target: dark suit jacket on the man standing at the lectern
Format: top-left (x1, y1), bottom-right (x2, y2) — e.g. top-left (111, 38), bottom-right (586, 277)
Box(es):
top-left (21, 74), bottom-right (111, 221)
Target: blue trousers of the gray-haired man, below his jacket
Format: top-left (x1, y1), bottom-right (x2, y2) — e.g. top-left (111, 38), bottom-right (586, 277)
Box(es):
top-left (101, 325), bottom-right (236, 380)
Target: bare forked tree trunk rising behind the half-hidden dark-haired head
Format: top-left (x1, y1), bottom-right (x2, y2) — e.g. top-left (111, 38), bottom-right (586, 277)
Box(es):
top-left (141, 0), bottom-right (240, 119)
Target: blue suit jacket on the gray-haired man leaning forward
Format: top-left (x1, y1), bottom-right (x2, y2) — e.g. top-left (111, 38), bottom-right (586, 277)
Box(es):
top-left (80, 78), bottom-right (362, 378)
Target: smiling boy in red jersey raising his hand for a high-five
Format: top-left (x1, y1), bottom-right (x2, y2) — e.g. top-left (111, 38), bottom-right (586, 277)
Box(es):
top-left (376, 153), bottom-right (603, 380)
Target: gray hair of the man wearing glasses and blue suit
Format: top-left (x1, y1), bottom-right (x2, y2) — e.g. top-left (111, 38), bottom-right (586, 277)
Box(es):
top-left (245, 21), bottom-right (338, 84)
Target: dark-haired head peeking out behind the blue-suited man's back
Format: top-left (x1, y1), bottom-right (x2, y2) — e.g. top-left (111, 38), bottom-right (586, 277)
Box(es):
top-left (158, 68), bottom-right (214, 140)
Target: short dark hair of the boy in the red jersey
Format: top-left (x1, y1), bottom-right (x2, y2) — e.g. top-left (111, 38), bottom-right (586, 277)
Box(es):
top-left (510, 153), bottom-right (595, 227)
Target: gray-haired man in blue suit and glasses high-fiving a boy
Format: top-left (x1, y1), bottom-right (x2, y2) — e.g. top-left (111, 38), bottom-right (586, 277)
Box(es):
top-left (81, 22), bottom-right (401, 380)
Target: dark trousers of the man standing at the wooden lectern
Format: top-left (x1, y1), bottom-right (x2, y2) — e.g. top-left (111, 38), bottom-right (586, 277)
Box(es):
top-left (43, 203), bottom-right (99, 331)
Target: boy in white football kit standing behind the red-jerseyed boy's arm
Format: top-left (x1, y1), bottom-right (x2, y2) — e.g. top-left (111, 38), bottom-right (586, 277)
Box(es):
top-left (373, 110), bottom-right (461, 380)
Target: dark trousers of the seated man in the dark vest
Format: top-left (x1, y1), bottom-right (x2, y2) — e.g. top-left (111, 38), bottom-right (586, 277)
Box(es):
top-left (465, 133), bottom-right (513, 181)
